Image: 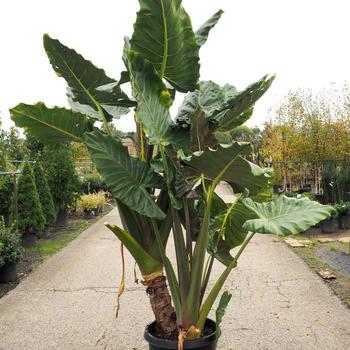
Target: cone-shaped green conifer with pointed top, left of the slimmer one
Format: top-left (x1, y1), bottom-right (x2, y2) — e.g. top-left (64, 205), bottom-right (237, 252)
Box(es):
top-left (18, 163), bottom-right (46, 235)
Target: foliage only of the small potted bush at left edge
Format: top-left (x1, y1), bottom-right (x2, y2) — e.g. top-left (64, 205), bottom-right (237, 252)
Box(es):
top-left (0, 216), bottom-right (22, 267)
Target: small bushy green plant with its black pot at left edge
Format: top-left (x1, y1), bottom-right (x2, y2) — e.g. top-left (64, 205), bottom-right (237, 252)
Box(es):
top-left (0, 216), bottom-right (22, 283)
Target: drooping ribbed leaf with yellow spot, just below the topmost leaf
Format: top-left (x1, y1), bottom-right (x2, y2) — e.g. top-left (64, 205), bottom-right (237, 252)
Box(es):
top-left (127, 51), bottom-right (172, 145)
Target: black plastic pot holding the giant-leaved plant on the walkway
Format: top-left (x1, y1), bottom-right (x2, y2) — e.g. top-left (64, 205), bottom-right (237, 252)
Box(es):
top-left (145, 319), bottom-right (216, 350)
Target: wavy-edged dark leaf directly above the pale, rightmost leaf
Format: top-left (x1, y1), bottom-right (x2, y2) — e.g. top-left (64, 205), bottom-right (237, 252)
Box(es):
top-left (185, 142), bottom-right (270, 195)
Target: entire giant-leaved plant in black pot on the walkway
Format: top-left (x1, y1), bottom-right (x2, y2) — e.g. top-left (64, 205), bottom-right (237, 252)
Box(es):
top-left (11, 0), bottom-right (332, 349)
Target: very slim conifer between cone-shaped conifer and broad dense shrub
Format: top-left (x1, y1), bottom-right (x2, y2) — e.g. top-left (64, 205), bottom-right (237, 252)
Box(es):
top-left (33, 162), bottom-right (56, 225)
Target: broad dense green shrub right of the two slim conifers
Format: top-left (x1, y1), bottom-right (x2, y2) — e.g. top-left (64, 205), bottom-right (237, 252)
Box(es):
top-left (43, 144), bottom-right (80, 211)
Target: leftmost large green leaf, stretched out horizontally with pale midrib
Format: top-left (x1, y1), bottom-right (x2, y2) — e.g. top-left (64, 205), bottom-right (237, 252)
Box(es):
top-left (10, 102), bottom-right (93, 143)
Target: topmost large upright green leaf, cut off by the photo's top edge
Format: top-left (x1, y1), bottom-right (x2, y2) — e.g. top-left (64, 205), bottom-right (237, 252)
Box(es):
top-left (130, 0), bottom-right (199, 92)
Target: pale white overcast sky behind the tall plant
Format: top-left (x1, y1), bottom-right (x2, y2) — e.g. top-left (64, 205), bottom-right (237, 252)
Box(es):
top-left (0, 0), bottom-right (350, 131)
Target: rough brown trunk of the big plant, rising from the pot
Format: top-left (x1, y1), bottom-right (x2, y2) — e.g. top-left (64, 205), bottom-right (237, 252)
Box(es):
top-left (144, 276), bottom-right (177, 336)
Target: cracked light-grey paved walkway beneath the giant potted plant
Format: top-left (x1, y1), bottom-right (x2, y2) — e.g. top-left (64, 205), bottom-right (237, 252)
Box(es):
top-left (0, 206), bottom-right (350, 350)
